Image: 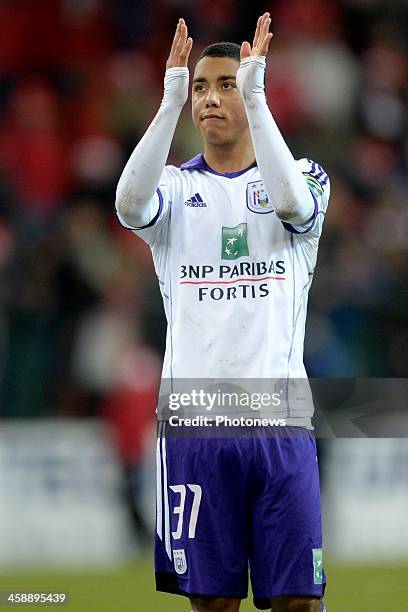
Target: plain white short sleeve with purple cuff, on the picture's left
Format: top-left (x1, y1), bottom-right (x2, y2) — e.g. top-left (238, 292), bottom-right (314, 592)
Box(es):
top-left (116, 167), bottom-right (171, 246)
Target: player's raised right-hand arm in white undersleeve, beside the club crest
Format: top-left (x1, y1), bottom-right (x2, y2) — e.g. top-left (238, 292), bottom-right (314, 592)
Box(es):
top-left (237, 13), bottom-right (314, 225)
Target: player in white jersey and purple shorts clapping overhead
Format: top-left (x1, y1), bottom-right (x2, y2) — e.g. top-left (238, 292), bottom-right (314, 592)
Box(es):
top-left (116, 13), bottom-right (329, 612)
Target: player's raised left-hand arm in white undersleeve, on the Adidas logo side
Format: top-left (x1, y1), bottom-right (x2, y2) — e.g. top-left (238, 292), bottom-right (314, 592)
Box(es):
top-left (116, 19), bottom-right (193, 227)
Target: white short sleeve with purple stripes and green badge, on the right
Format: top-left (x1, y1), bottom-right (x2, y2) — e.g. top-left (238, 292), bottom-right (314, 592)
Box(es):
top-left (283, 158), bottom-right (330, 238)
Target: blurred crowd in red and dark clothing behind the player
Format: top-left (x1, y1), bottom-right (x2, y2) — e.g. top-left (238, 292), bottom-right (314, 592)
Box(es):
top-left (0, 0), bottom-right (408, 430)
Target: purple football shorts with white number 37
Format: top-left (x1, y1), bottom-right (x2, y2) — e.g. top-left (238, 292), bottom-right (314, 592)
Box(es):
top-left (155, 423), bottom-right (326, 610)
